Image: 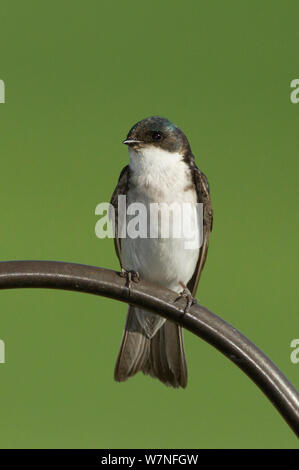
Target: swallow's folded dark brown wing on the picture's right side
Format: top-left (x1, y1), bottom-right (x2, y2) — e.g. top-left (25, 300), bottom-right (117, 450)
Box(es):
top-left (187, 164), bottom-right (213, 296)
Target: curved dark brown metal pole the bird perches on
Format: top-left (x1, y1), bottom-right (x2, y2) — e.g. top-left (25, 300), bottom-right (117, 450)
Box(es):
top-left (0, 261), bottom-right (299, 437)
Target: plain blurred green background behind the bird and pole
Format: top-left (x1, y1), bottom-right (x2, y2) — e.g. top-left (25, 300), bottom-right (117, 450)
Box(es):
top-left (0, 0), bottom-right (299, 448)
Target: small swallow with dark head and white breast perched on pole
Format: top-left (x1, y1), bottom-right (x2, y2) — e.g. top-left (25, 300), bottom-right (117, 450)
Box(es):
top-left (110, 116), bottom-right (213, 388)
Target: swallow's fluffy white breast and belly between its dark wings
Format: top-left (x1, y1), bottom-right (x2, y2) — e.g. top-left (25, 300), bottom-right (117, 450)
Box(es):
top-left (121, 146), bottom-right (199, 292)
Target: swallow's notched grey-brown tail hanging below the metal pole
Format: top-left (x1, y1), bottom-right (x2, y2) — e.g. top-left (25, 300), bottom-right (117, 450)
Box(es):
top-left (114, 306), bottom-right (187, 388)
